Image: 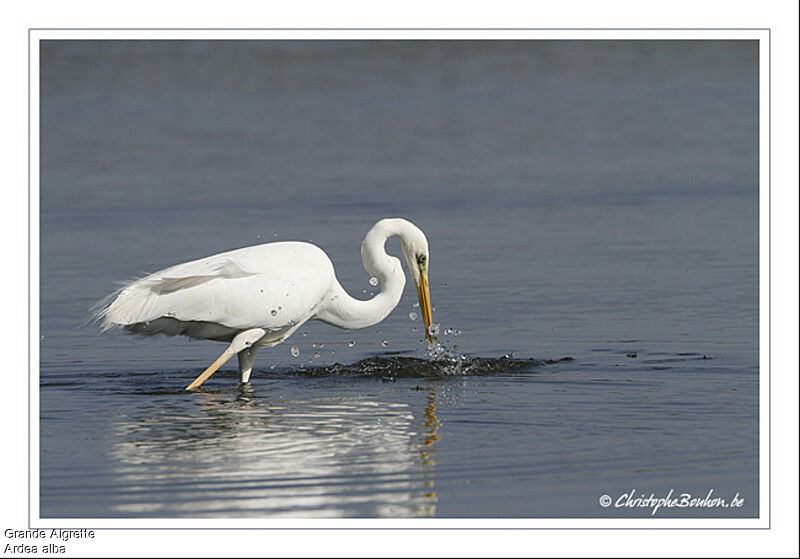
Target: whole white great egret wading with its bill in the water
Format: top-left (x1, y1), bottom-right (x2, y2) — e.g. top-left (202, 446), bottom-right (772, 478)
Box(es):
top-left (94, 219), bottom-right (432, 390)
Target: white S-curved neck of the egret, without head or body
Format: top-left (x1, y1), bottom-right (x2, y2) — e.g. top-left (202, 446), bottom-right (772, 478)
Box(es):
top-left (316, 220), bottom-right (406, 330)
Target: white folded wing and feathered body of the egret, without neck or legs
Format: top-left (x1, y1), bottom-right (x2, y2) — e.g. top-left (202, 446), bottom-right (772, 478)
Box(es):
top-left (95, 242), bottom-right (334, 339)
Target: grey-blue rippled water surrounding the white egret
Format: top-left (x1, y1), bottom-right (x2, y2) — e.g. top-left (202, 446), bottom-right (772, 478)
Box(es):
top-left (40, 41), bottom-right (759, 518)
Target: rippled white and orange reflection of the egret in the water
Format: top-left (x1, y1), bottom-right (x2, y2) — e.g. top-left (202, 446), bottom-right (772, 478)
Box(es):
top-left (113, 390), bottom-right (439, 517)
